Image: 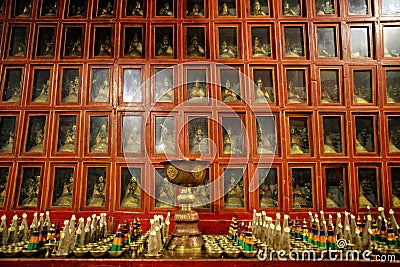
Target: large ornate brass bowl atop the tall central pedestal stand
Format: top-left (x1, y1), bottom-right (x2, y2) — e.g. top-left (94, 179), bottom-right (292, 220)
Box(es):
top-left (163, 160), bottom-right (210, 187)
